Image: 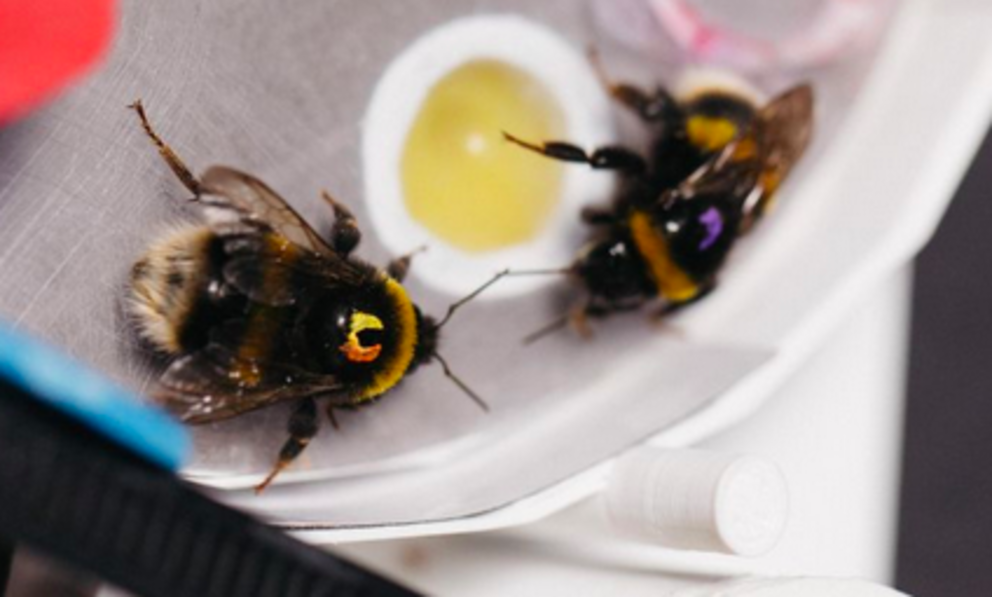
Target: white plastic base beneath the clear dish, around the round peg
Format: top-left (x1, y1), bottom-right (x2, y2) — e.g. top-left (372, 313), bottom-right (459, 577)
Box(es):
top-left (336, 267), bottom-right (912, 596)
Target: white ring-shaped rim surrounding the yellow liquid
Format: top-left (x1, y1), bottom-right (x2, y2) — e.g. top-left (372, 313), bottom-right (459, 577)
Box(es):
top-left (362, 15), bottom-right (614, 299)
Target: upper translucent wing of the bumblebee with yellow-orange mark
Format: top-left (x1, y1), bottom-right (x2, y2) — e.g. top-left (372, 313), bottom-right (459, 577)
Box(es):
top-left (200, 166), bottom-right (337, 257)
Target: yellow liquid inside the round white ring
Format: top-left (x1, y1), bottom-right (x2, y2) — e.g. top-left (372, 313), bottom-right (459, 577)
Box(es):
top-left (402, 60), bottom-right (564, 251)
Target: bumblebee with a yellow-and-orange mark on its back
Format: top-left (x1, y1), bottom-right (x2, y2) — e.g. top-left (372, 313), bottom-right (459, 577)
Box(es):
top-left (129, 101), bottom-right (499, 492)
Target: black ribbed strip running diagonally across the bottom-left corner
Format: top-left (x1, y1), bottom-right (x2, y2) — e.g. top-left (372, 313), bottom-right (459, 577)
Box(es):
top-left (0, 383), bottom-right (415, 597)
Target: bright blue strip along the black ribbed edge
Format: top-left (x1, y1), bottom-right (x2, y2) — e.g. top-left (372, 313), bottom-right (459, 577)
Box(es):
top-left (0, 322), bottom-right (191, 470)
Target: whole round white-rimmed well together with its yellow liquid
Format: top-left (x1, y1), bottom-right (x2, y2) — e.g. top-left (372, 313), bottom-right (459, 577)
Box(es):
top-left (362, 16), bottom-right (613, 297)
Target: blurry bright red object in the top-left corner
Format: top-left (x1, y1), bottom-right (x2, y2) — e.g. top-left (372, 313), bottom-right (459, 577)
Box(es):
top-left (0, 0), bottom-right (115, 123)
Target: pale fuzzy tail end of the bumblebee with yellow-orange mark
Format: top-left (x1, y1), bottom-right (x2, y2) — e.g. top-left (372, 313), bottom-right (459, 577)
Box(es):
top-left (128, 225), bottom-right (216, 354)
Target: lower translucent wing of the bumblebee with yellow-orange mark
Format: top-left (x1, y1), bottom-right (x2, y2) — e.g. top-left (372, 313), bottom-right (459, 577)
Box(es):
top-left (154, 343), bottom-right (348, 424)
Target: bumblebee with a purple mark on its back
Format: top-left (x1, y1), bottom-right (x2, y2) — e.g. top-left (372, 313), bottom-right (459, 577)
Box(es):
top-left (504, 70), bottom-right (814, 338)
